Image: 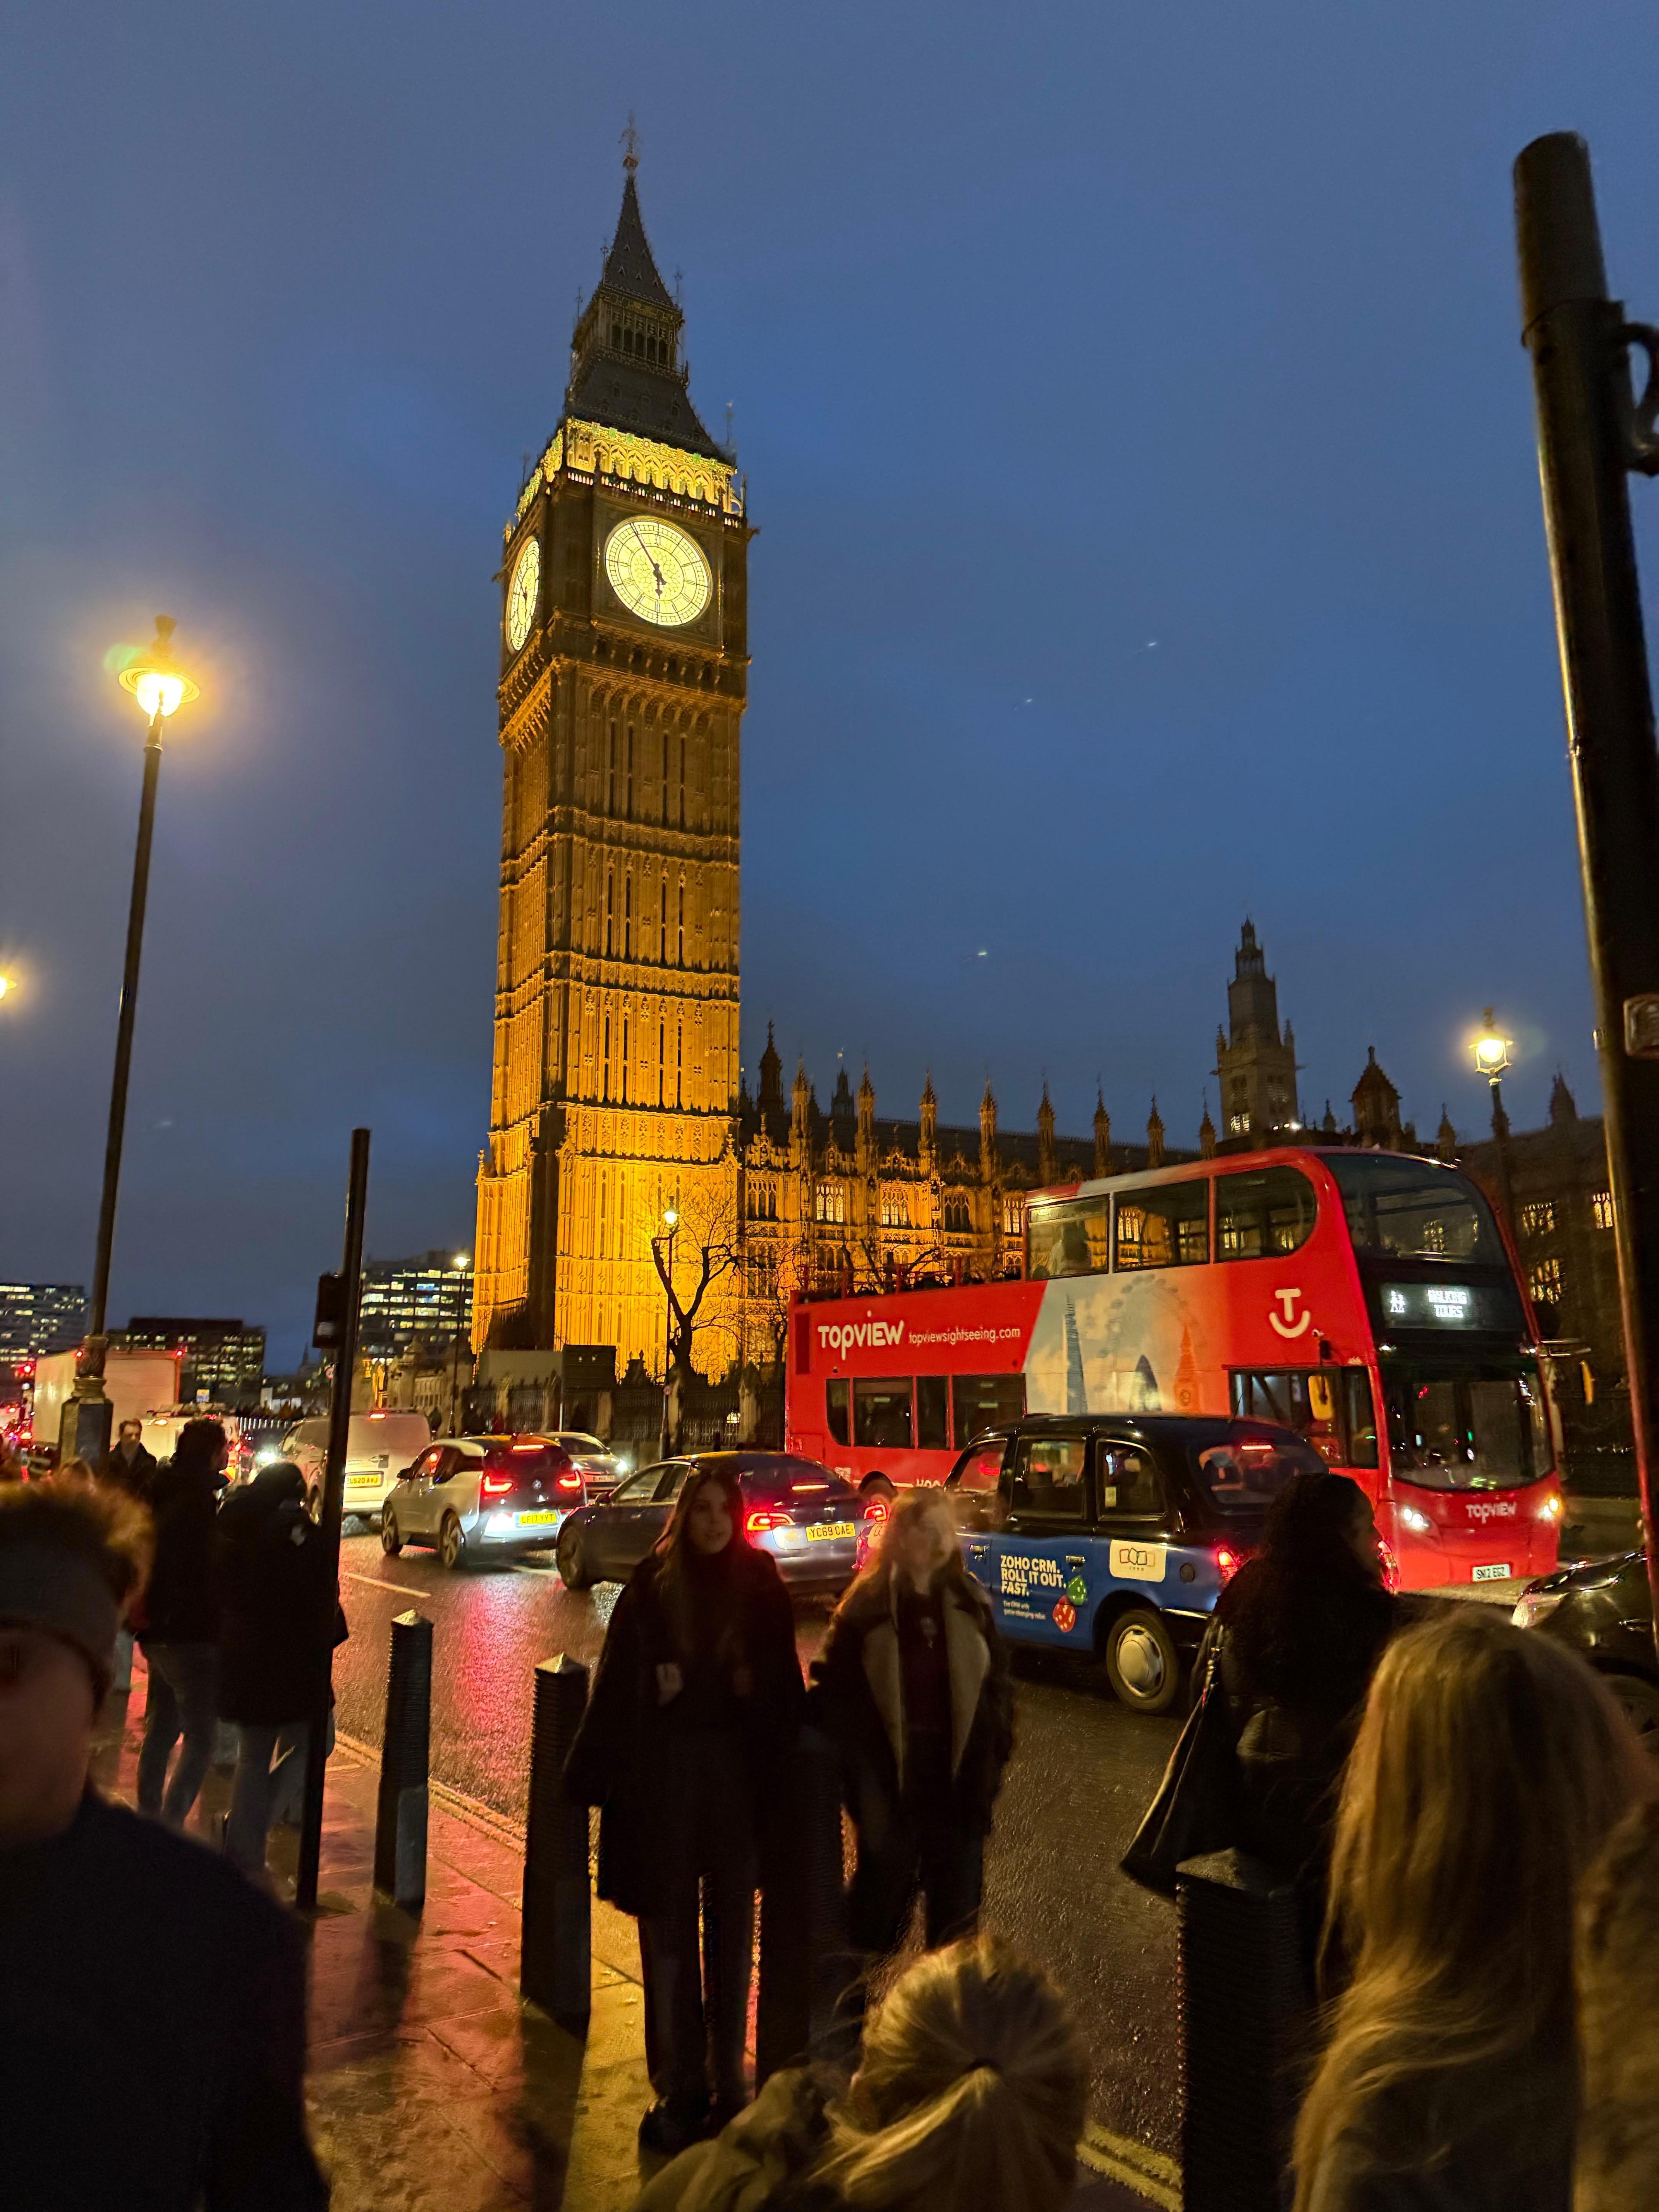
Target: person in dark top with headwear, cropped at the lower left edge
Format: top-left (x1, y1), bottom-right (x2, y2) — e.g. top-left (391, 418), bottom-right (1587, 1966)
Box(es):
top-left (0, 1478), bottom-right (327, 2212)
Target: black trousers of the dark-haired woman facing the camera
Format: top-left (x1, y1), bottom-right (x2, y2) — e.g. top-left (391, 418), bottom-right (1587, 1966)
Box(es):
top-left (639, 1732), bottom-right (754, 2104)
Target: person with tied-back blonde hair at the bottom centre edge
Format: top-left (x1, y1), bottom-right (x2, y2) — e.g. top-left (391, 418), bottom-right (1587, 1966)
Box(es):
top-left (635, 1936), bottom-right (1088, 2212)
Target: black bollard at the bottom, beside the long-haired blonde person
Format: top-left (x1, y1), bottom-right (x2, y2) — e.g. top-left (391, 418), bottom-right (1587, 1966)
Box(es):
top-left (1175, 1851), bottom-right (1310, 2212)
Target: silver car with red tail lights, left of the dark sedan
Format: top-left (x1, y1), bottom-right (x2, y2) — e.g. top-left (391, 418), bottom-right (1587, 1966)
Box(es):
top-left (380, 1436), bottom-right (584, 1568)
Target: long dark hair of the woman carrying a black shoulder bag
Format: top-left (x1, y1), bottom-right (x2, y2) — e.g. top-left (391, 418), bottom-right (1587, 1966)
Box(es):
top-left (1219, 1469), bottom-right (1394, 1712)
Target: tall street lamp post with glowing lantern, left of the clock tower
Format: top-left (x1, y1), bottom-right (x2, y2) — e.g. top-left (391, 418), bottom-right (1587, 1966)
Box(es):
top-left (58, 615), bottom-right (199, 1464)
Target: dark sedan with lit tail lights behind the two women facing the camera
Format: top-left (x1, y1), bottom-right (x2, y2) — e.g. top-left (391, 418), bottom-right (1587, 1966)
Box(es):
top-left (557, 1451), bottom-right (865, 1593)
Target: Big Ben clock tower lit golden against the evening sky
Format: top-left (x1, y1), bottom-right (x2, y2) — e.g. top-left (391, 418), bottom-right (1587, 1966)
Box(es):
top-left (473, 153), bottom-right (750, 1367)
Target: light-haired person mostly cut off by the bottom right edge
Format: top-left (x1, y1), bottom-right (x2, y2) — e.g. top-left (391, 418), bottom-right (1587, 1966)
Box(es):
top-left (1573, 1798), bottom-right (1659, 2212)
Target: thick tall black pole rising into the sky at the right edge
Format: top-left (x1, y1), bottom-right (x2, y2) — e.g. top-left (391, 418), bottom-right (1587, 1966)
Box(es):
top-left (1515, 131), bottom-right (1659, 1619)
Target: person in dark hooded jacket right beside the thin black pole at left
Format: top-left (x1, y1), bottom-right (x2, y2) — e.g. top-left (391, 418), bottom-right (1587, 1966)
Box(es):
top-left (219, 1460), bottom-right (345, 1874)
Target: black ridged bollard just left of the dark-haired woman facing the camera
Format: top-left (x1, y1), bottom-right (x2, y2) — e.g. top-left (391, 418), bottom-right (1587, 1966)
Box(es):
top-left (518, 1652), bottom-right (593, 2028)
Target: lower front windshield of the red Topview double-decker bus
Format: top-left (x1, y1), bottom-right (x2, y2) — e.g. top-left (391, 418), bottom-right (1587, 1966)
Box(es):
top-left (1382, 1360), bottom-right (1551, 1491)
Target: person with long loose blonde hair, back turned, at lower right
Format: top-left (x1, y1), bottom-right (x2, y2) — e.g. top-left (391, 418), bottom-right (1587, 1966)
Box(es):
top-left (1294, 1606), bottom-right (1650, 2212)
